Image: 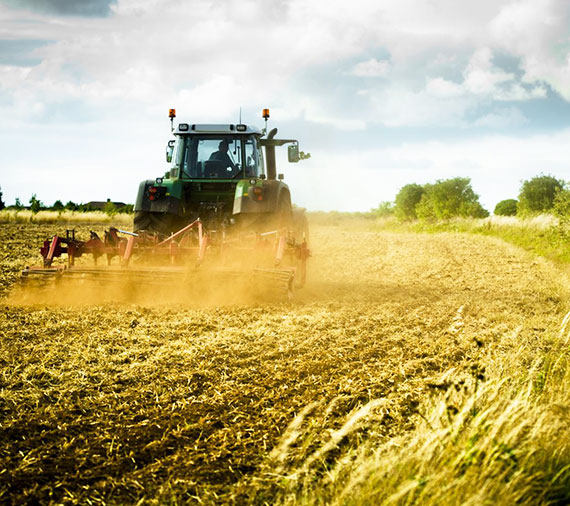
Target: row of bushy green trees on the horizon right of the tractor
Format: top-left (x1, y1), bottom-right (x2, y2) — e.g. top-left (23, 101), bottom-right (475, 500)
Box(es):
top-left (372, 174), bottom-right (570, 221)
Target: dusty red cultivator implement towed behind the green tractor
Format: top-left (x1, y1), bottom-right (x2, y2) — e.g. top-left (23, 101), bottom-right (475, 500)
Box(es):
top-left (21, 219), bottom-right (310, 297)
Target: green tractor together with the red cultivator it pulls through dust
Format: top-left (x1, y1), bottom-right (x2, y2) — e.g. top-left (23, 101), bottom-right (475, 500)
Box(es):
top-left (22, 109), bottom-right (311, 297)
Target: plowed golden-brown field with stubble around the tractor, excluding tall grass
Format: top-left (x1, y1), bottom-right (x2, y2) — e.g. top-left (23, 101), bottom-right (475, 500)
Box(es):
top-left (0, 220), bottom-right (564, 504)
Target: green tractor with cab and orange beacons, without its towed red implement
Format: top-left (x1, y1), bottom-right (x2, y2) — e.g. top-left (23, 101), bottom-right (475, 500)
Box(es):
top-left (134, 109), bottom-right (310, 242)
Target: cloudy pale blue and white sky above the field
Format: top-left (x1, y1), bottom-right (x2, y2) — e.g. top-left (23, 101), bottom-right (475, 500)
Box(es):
top-left (0, 0), bottom-right (570, 211)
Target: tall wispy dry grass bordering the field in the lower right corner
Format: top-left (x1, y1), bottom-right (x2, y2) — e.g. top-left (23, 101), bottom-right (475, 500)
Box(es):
top-left (266, 314), bottom-right (570, 505)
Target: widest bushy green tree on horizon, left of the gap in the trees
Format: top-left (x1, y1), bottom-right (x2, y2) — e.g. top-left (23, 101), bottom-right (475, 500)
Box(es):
top-left (416, 177), bottom-right (489, 220)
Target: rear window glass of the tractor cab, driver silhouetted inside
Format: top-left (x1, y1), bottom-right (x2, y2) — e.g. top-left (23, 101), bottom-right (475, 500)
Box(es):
top-left (171, 135), bottom-right (259, 179)
